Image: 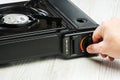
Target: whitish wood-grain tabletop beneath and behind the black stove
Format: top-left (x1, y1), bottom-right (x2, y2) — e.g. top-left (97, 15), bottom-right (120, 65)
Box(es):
top-left (0, 0), bottom-right (120, 80)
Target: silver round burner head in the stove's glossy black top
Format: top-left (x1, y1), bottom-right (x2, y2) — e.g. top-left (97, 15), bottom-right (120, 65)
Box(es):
top-left (3, 14), bottom-right (29, 24)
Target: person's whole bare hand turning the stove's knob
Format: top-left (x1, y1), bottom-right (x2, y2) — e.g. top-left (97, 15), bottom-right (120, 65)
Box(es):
top-left (87, 18), bottom-right (120, 61)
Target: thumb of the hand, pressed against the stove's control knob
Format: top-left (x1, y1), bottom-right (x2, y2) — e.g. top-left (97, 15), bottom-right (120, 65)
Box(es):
top-left (87, 41), bottom-right (105, 54)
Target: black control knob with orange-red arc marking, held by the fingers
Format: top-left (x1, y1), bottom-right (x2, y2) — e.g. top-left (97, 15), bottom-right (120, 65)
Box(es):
top-left (80, 35), bottom-right (93, 52)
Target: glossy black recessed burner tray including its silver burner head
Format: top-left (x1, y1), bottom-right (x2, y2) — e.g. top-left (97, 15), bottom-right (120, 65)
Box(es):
top-left (0, 6), bottom-right (62, 35)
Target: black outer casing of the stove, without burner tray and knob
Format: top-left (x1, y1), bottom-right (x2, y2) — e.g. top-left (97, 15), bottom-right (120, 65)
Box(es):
top-left (0, 0), bottom-right (98, 64)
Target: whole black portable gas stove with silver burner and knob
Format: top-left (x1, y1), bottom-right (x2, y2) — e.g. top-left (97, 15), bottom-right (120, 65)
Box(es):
top-left (0, 0), bottom-right (98, 64)
